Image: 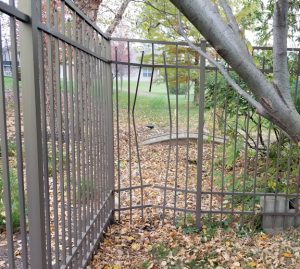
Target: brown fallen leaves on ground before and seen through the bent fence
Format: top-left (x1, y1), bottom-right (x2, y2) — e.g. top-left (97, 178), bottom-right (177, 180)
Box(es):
top-left (89, 120), bottom-right (300, 269)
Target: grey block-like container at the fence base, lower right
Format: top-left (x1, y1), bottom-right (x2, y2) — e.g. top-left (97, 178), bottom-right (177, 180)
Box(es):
top-left (260, 196), bottom-right (300, 234)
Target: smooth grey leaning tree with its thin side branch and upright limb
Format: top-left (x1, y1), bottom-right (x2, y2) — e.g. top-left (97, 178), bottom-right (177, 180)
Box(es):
top-left (171, 0), bottom-right (300, 145)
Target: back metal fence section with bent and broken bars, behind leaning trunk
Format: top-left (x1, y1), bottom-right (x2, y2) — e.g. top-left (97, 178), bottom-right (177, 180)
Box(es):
top-left (112, 38), bottom-right (300, 232)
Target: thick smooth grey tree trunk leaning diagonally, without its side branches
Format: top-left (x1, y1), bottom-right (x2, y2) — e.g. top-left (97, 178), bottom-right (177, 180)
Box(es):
top-left (171, 0), bottom-right (300, 144)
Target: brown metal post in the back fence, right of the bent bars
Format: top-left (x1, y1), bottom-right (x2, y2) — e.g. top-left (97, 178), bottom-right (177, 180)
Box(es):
top-left (196, 40), bottom-right (206, 229)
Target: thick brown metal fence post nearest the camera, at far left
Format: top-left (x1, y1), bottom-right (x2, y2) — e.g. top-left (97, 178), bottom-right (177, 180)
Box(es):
top-left (19, 0), bottom-right (46, 269)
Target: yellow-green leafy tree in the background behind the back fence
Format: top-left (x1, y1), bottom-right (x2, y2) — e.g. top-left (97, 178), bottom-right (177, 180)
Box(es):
top-left (136, 0), bottom-right (261, 104)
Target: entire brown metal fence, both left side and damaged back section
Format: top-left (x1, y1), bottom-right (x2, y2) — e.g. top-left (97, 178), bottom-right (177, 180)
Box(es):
top-left (0, 0), bottom-right (300, 269)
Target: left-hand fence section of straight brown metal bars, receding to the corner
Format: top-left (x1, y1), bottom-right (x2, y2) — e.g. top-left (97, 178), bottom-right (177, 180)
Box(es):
top-left (0, 0), bottom-right (114, 269)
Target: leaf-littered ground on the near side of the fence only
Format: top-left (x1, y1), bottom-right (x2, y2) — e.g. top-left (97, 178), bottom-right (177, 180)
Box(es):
top-left (90, 213), bottom-right (300, 269)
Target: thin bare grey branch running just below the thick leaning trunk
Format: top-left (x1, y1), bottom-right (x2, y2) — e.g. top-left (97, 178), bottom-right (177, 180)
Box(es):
top-left (178, 13), bottom-right (267, 117)
